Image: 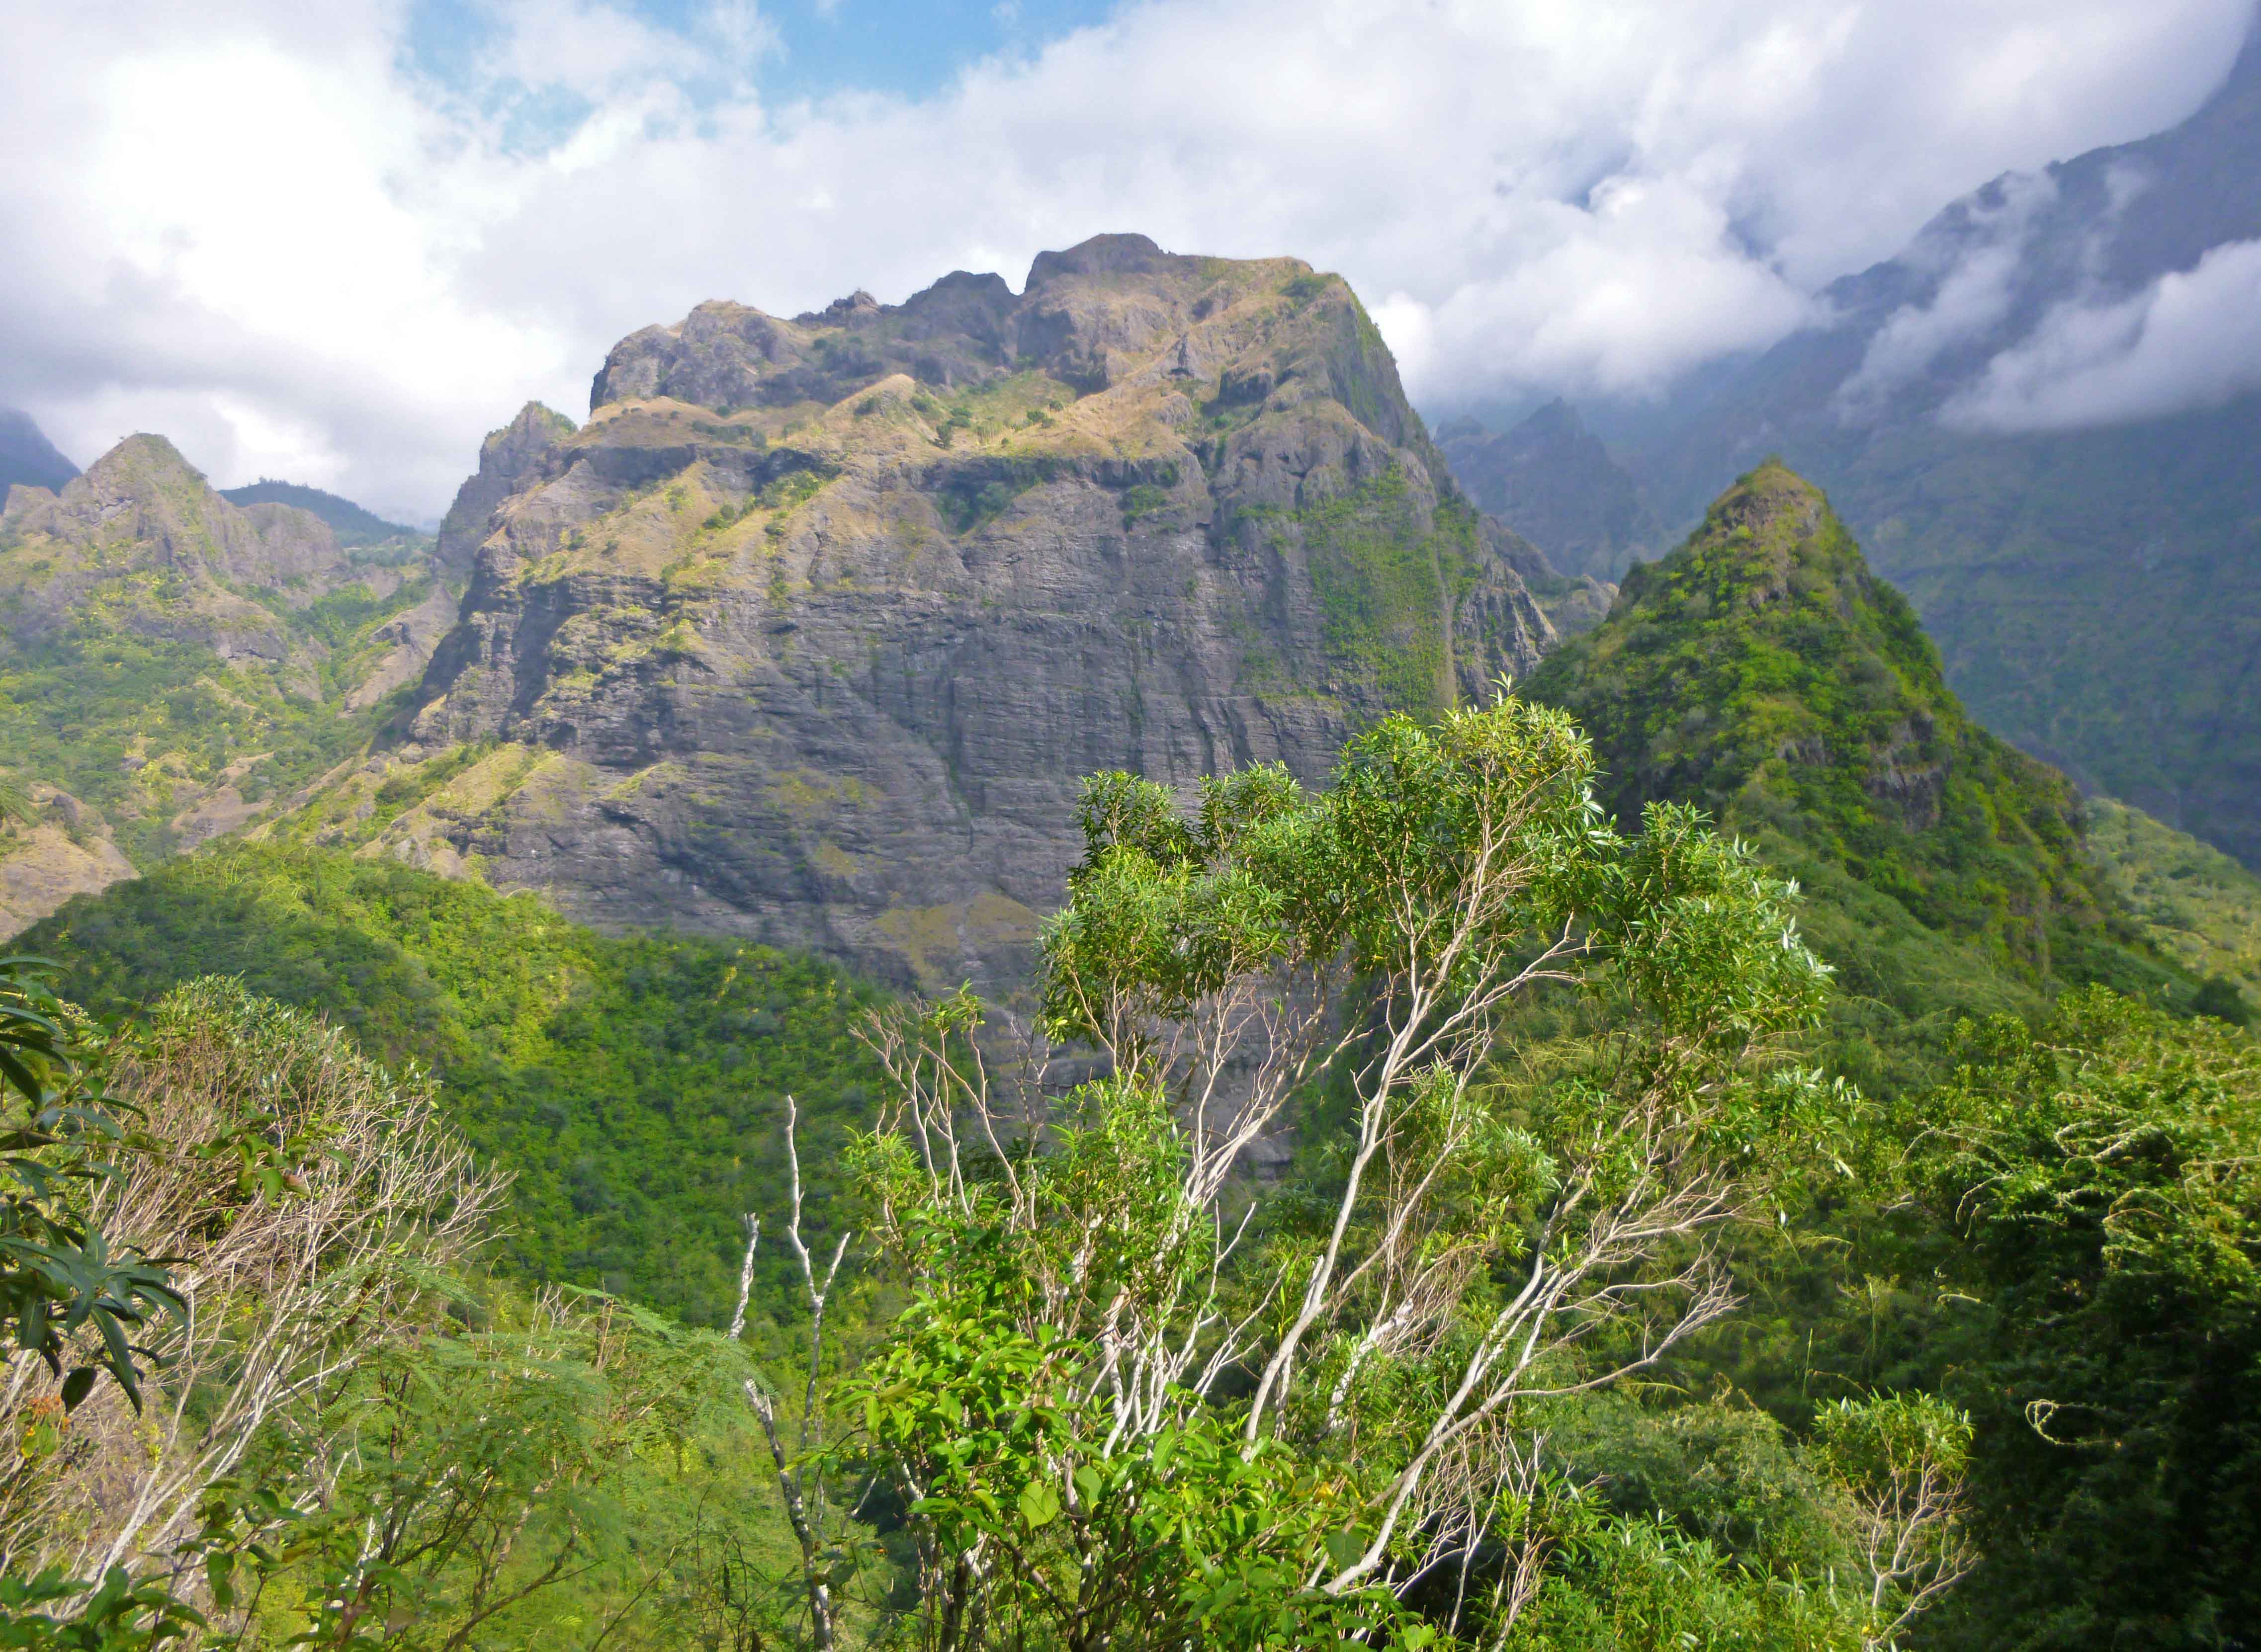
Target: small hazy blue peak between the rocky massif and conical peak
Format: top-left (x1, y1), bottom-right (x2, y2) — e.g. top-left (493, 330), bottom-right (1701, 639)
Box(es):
top-left (1436, 400), bottom-right (1664, 581)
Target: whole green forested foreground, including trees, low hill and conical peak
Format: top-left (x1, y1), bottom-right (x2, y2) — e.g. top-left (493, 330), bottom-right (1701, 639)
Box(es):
top-left (0, 452), bottom-right (2261, 1652)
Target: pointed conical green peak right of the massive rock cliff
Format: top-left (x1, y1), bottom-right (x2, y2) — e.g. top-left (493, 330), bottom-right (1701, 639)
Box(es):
top-left (1526, 463), bottom-right (2096, 970)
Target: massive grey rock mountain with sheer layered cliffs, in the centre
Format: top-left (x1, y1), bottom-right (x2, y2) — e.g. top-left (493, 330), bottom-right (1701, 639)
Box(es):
top-left (271, 235), bottom-right (1598, 988)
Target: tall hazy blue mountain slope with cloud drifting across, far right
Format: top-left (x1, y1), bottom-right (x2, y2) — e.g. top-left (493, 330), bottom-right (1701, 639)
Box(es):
top-left (1633, 29), bottom-right (2261, 866)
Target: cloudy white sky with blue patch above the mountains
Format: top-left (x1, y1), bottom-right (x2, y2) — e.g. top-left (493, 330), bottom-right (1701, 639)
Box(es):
top-left (0, 0), bottom-right (2261, 522)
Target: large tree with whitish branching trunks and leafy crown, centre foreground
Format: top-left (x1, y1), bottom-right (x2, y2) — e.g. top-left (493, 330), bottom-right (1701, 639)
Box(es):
top-left (841, 696), bottom-right (1829, 1648)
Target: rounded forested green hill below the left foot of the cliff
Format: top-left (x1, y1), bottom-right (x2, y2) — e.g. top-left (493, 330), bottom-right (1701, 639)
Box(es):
top-left (20, 845), bottom-right (875, 1322)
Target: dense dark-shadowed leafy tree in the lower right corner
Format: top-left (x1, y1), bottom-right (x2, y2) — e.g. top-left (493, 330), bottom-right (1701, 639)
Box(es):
top-left (1909, 990), bottom-right (2261, 1648)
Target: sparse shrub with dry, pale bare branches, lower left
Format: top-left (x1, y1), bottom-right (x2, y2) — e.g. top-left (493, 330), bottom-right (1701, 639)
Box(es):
top-left (0, 981), bottom-right (502, 1577)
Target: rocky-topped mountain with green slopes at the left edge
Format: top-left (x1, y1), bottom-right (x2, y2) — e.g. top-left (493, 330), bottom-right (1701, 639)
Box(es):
top-left (0, 436), bottom-right (454, 890)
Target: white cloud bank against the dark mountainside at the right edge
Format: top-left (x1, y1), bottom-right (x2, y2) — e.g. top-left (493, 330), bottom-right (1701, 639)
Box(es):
top-left (1944, 242), bottom-right (2261, 432)
